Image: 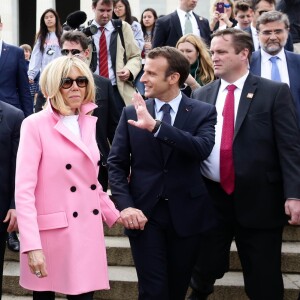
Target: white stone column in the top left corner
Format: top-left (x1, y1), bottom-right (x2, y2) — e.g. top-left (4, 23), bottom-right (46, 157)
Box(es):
top-left (0, 0), bottom-right (19, 46)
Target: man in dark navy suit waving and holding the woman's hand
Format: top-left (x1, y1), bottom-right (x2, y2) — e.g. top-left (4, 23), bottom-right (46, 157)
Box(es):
top-left (108, 47), bottom-right (216, 300)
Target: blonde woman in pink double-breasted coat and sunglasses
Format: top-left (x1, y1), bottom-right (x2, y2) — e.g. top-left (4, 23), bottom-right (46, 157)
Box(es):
top-left (16, 56), bottom-right (121, 300)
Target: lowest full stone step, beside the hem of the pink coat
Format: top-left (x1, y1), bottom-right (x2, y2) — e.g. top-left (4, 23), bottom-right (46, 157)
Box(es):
top-left (2, 262), bottom-right (300, 300)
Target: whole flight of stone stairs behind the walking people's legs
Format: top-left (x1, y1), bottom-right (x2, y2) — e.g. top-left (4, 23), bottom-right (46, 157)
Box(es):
top-left (2, 225), bottom-right (300, 300)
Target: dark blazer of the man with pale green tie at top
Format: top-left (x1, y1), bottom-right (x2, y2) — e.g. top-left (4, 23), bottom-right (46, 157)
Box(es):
top-left (152, 11), bottom-right (211, 48)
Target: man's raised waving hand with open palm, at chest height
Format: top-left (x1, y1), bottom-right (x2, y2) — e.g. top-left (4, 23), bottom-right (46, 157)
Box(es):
top-left (128, 93), bottom-right (156, 132)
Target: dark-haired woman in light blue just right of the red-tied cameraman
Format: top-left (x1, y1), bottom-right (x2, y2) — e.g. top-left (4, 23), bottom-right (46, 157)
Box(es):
top-left (113, 0), bottom-right (144, 51)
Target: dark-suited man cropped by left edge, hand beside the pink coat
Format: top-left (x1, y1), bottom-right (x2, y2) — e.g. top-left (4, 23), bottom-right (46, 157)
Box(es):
top-left (0, 101), bottom-right (24, 298)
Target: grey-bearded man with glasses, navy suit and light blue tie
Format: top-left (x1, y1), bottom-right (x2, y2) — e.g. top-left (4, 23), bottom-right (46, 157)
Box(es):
top-left (250, 10), bottom-right (300, 124)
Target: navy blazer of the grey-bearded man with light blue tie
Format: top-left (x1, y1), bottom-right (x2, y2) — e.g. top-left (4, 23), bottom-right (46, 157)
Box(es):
top-left (250, 50), bottom-right (300, 124)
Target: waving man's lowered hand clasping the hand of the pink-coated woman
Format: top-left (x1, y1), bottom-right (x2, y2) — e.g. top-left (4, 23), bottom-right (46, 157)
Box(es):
top-left (120, 207), bottom-right (148, 230)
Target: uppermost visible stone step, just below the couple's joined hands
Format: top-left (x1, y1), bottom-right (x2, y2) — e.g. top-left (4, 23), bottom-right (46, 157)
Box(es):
top-left (104, 224), bottom-right (300, 242)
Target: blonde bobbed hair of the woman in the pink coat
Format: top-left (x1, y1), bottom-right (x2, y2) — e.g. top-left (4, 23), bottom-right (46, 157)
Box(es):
top-left (40, 56), bottom-right (95, 115)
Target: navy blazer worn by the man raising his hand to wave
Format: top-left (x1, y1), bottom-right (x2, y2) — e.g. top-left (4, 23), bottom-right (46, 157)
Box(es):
top-left (108, 95), bottom-right (216, 236)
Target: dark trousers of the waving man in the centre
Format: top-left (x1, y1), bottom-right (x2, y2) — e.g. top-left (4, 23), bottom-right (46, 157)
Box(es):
top-left (129, 200), bottom-right (201, 300)
